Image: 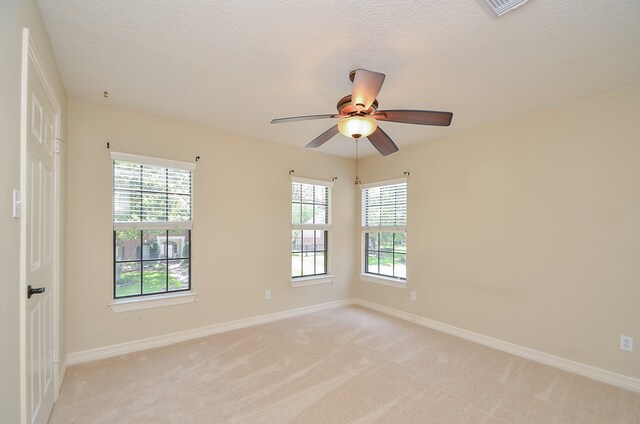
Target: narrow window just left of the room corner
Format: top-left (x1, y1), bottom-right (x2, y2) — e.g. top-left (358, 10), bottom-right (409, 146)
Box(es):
top-left (291, 178), bottom-right (331, 279)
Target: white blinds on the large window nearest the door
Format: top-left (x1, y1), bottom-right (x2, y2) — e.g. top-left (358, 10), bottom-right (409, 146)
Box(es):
top-left (112, 154), bottom-right (192, 229)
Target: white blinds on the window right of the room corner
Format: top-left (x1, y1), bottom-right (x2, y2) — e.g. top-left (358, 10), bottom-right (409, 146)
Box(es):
top-left (362, 179), bottom-right (407, 232)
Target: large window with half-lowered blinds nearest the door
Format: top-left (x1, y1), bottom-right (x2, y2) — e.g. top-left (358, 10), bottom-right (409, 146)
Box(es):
top-left (111, 152), bottom-right (195, 299)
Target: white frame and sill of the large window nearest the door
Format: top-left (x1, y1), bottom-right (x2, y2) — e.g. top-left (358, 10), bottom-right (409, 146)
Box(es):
top-left (109, 152), bottom-right (197, 304)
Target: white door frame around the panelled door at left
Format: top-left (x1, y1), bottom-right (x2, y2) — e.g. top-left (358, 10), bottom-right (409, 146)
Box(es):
top-left (19, 28), bottom-right (62, 424)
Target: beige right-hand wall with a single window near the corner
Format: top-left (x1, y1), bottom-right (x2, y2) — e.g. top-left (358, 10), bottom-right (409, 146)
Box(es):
top-left (356, 85), bottom-right (640, 378)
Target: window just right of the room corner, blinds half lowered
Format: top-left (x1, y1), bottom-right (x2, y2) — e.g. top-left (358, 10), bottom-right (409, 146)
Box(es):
top-left (362, 179), bottom-right (407, 280)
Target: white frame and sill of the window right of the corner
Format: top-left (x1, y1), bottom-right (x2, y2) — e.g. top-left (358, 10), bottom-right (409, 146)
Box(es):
top-left (360, 178), bottom-right (409, 288)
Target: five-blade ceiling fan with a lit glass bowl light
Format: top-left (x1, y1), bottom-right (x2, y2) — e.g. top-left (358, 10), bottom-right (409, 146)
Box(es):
top-left (271, 69), bottom-right (453, 156)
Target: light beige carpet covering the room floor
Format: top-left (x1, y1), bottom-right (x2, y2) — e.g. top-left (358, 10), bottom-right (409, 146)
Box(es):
top-left (50, 306), bottom-right (640, 424)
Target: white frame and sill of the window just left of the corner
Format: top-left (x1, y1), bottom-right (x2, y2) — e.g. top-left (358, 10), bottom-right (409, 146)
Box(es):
top-left (289, 176), bottom-right (333, 287)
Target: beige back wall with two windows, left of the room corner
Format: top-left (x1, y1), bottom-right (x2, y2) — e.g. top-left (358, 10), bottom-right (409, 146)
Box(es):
top-left (67, 98), bottom-right (356, 352)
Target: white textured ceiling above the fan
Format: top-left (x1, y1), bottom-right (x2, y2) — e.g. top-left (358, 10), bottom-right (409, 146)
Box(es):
top-left (38, 0), bottom-right (640, 157)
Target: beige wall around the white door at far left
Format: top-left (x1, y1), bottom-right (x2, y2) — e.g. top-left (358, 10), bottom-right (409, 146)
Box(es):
top-left (0, 0), bottom-right (66, 423)
